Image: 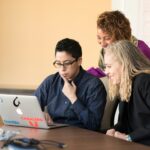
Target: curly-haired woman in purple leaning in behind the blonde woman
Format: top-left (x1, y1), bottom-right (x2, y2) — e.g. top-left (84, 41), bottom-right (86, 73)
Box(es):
top-left (88, 10), bottom-right (150, 77)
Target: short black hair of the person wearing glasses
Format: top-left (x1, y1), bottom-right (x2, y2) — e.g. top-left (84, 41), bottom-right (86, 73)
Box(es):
top-left (55, 38), bottom-right (82, 59)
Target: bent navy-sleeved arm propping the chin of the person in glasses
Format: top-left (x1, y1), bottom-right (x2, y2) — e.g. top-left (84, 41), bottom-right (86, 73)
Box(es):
top-left (73, 79), bottom-right (106, 130)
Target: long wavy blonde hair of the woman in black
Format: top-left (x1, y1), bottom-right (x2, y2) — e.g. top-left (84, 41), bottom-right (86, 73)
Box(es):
top-left (104, 40), bottom-right (150, 102)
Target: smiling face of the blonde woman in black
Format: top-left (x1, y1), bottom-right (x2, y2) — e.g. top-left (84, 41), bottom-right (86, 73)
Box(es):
top-left (104, 52), bottom-right (123, 85)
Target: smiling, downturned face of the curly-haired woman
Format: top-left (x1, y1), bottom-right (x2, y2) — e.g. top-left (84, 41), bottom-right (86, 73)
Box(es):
top-left (97, 28), bottom-right (114, 48)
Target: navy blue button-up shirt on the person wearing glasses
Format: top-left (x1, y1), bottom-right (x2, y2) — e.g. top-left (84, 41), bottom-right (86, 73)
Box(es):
top-left (35, 67), bottom-right (106, 130)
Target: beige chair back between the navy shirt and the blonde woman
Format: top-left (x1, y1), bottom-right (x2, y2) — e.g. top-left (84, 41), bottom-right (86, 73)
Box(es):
top-left (100, 77), bottom-right (119, 133)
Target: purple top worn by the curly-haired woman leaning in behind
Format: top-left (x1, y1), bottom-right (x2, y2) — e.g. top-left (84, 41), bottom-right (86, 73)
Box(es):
top-left (87, 40), bottom-right (150, 78)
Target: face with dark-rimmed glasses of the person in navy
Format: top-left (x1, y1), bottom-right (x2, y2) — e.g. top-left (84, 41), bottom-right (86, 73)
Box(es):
top-left (54, 51), bottom-right (82, 80)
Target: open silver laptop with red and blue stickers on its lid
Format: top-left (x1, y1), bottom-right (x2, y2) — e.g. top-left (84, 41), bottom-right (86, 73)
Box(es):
top-left (0, 94), bottom-right (68, 129)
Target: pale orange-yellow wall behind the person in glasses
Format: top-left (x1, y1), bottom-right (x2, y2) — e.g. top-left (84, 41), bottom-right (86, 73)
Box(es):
top-left (0, 0), bottom-right (111, 89)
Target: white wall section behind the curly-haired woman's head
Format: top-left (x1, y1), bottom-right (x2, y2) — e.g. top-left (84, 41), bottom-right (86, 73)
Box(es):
top-left (112, 0), bottom-right (150, 46)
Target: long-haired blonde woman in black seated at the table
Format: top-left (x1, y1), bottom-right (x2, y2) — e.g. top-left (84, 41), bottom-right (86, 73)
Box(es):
top-left (104, 40), bottom-right (150, 145)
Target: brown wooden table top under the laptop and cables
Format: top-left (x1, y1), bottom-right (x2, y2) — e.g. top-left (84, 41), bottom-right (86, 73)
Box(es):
top-left (0, 126), bottom-right (150, 150)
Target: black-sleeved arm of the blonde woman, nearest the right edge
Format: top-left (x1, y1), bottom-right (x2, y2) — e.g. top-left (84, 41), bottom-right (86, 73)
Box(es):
top-left (129, 75), bottom-right (150, 141)
